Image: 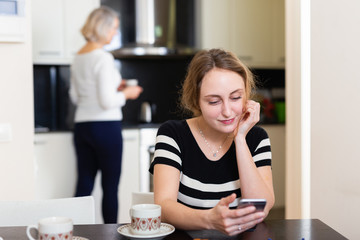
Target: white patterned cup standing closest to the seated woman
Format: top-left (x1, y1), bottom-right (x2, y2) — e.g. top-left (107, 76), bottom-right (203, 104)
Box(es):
top-left (130, 204), bottom-right (161, 235)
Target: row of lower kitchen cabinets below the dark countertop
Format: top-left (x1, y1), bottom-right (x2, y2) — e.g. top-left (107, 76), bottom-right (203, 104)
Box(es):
top-left (34, 124), bottom-right (285, 218)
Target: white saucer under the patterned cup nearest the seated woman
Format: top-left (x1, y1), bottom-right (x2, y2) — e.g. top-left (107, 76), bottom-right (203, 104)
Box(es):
top-left (118, 223), bottom-right (175, 240)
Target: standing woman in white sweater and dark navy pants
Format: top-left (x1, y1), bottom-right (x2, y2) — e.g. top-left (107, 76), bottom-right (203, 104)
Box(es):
top-left (70, 7), bottom-right (142, 223)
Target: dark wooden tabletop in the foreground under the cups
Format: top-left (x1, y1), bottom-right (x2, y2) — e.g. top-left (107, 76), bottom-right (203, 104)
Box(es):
top-left (0, 219), bottom-right (347, 240)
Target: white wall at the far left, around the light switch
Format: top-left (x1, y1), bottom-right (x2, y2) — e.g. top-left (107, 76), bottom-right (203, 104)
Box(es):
top-left (0, 0), bottom-right (34, 200)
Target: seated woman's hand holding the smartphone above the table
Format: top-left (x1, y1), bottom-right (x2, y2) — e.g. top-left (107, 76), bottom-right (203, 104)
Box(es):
top-left (209, 193), bottom-right (265, 236)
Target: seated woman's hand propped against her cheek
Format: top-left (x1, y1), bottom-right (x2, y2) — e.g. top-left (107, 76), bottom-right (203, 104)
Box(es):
top-left (235, 100), bottom-right (260, 138)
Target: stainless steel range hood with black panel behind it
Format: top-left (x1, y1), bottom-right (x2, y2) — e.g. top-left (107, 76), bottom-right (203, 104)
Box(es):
top-left (107, 0), bottom-right (196, 57)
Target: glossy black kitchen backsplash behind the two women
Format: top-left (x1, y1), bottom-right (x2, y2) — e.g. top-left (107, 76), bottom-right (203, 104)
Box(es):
top-left (34, 60), bottom-right (285, 131)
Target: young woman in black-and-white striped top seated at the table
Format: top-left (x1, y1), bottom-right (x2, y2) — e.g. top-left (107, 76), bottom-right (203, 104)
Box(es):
top-left (150, 49), bottom-right (275, 235)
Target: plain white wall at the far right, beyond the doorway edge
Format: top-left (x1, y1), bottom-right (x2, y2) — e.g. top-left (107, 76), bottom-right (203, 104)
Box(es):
top-left (311, 0), bottom-right (360, 239)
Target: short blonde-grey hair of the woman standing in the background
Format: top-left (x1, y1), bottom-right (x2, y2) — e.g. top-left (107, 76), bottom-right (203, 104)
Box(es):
top-left (81, 6), bottom-right (119, 42)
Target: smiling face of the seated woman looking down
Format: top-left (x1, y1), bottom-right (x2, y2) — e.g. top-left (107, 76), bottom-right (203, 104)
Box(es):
top-left (199, 68), bottom-right (246, 133)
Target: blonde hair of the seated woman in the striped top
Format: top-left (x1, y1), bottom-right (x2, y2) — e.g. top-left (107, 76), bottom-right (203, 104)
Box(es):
top-left (180, 49), bottom-right (256, 116)
